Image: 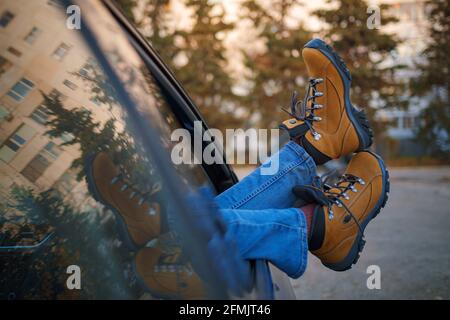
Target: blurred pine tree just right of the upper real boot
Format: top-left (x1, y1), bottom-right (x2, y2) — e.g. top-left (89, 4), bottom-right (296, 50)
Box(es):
top-left (314, 0), bottom-right (406, 141)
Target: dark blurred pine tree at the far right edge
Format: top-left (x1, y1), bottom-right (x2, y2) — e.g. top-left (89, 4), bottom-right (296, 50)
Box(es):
top-left (412, 0), bottom-right (450, 160)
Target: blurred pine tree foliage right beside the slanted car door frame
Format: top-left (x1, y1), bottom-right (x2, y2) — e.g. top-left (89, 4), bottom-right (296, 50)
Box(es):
top-left (119, 0), bottom-right (240, 129)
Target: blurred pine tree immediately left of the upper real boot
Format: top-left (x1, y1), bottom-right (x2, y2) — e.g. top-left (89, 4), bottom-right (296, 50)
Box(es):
top-left (243, 0), bottom-right (310, 128)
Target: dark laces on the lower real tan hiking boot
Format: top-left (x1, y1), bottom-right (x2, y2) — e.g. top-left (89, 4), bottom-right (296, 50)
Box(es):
top-left (322, 173), bottom-right (365, 237)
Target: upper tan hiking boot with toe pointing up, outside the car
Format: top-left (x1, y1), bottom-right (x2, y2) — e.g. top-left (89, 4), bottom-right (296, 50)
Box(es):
top-left (280, 39), bottom-right (372, 164)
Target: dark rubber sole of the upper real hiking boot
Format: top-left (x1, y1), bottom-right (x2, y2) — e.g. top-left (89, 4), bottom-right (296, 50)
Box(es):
top-left (304, 39), bottom-right (373, 151)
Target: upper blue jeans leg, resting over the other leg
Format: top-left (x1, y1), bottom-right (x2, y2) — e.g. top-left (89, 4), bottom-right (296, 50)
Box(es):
top-left (215, 141), bottom-right (317, 210)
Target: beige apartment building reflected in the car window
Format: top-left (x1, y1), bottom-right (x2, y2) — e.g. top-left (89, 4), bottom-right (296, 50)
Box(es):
top-left (0, 0), bottom-right (107, 212)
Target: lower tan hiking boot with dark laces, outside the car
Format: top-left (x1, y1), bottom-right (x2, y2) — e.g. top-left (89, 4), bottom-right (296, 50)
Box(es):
top-left (293, 151), bottom-right (389, 271)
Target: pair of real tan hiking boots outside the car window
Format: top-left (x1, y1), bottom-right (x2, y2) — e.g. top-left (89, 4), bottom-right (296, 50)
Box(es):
top-left (280, 39), bottom-right (389, 271)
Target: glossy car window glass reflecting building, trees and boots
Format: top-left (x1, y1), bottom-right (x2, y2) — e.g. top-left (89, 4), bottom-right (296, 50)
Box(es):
top-left (0, 0), bottom-right (221, 299)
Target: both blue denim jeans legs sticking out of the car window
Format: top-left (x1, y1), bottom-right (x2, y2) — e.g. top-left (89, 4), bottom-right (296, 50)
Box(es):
top-left (215, 142), bottom-right (316, 278)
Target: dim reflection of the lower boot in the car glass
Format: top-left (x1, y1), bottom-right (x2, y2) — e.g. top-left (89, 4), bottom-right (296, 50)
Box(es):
top-left (134, 247), bottom-right (206, 299)
